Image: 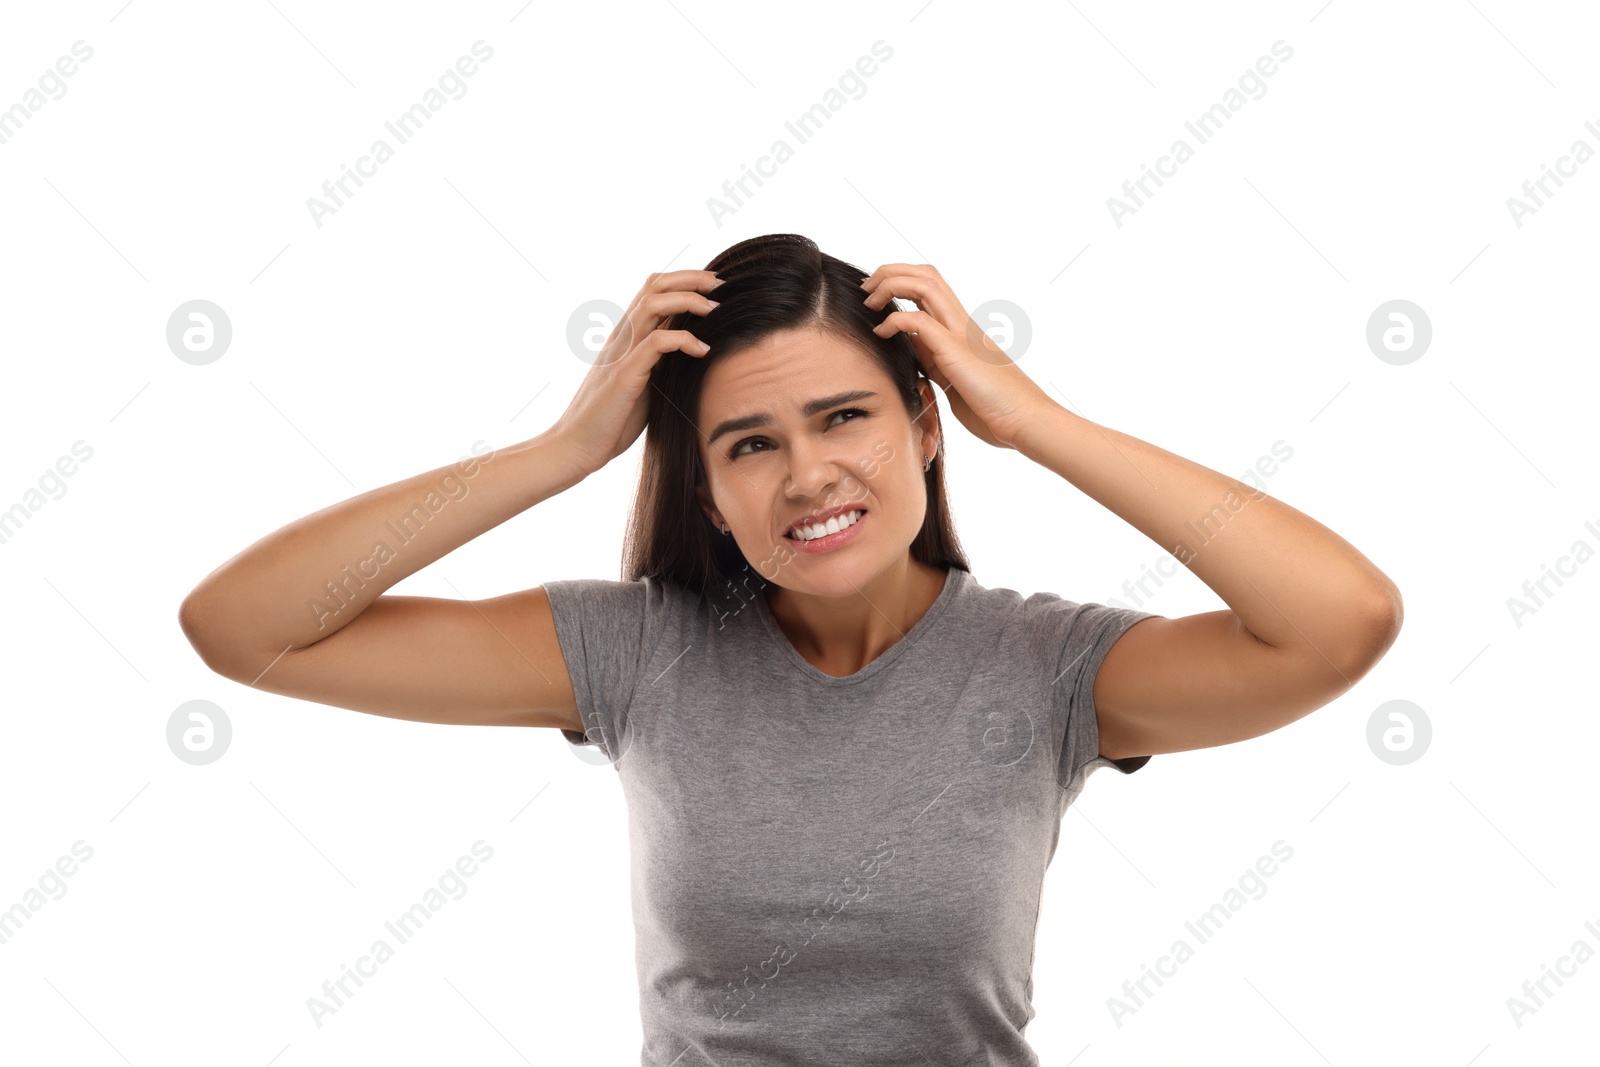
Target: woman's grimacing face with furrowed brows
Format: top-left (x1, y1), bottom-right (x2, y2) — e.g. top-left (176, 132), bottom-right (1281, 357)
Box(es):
top-left (696, 328), bottom-right (939, 597)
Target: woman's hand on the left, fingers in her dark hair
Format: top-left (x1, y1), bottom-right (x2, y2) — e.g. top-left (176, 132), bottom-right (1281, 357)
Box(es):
top-left (549, 270), bottom-right (722, 474)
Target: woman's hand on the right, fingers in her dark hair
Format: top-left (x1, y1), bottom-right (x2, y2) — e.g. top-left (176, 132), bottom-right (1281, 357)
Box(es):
top-left (861, 262), bottom-right (1051, 448)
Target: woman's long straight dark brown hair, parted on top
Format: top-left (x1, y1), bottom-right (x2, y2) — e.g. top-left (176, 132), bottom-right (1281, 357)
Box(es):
top-left (622, 234), bottom-right (971, 614)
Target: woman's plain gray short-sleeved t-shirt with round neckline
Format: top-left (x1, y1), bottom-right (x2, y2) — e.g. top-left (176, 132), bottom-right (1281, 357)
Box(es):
top-left (544, 568), bottom-right (1152, 1067)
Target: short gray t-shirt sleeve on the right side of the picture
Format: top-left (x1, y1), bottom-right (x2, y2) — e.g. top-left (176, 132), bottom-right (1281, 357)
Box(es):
top-left (1027, 593), bottom-right (1157, 803)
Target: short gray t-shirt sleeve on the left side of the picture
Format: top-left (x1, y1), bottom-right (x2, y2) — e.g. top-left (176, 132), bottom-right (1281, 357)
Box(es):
top-left (531, 577), bottom-right (670, 765)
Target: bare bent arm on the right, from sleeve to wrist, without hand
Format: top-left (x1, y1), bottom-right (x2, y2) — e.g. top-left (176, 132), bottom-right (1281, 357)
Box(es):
top-left (1013, 403), bottom-right (1403, 760)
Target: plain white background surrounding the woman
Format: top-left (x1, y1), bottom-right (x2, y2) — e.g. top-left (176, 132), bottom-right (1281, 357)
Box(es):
top-left (0, 0), bottom-right (1600, 1067)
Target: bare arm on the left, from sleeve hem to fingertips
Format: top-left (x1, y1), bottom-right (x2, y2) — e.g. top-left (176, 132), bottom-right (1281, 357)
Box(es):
top-left (178, 270), bottom-right (720, 731)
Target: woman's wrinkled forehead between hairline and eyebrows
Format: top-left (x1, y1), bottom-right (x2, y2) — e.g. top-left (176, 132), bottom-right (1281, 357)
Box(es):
top-left (699, 328), bottom-right (893, 427)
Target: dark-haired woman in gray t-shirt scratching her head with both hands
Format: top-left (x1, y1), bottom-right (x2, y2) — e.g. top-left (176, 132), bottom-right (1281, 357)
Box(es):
top-left (181, 235), bottom-right (1402, 1067)
